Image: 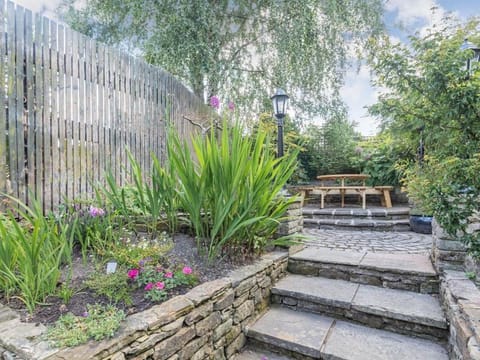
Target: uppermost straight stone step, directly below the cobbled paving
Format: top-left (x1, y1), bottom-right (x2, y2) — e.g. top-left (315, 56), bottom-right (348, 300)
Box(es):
top-left (288, 247), bottom-right (439, 294)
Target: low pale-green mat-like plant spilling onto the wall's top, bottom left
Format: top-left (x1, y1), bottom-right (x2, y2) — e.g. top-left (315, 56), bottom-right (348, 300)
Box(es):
top-left (45, 305), bottom-right (125, 347)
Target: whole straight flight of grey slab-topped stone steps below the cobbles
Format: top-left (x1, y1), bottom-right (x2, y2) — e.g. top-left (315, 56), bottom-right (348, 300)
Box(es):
top-left (235, 248), bottom-right (448, 360)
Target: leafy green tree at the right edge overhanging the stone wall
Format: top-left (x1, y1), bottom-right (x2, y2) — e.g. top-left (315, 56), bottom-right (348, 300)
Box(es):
top-left (371, 19), bottom-right (480, 256)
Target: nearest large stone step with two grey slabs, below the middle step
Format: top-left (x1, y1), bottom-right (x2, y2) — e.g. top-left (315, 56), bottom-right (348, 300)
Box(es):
top-left (247, 307), bottom-right (448, 360)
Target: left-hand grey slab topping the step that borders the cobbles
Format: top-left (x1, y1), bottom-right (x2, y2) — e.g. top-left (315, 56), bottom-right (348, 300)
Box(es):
top-left (290, 247), bottom-right (365, 266)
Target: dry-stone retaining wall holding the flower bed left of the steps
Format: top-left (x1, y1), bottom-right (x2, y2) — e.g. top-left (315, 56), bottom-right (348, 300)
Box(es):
top-left (0, 252), bottom-right (288, 360)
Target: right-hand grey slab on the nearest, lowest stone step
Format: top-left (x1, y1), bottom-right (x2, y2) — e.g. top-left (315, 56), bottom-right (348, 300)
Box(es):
top-left (321, 321), bottom-right (448, 360)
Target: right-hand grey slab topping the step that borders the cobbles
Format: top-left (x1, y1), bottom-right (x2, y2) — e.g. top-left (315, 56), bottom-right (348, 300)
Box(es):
top-left (359, 252), bottom-right (436, 276)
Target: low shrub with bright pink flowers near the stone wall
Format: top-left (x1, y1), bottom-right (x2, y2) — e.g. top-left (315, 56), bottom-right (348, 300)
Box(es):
top-left (127, 259), bottom-right (197, 302)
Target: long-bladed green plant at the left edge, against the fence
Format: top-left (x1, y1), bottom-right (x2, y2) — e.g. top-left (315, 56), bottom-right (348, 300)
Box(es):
top-left (0, 197), bottom-right (74, 312)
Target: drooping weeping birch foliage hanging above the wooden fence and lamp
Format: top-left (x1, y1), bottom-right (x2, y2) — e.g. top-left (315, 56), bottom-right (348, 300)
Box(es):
top-left (60, 0), bottom-right (383, 120)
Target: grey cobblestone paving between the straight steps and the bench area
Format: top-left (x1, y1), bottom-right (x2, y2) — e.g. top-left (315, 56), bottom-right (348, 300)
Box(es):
top-left (303, 228), bottom-right (432, 254)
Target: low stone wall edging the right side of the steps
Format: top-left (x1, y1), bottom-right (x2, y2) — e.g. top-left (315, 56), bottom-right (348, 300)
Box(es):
top-left (440, 270), bottom-right (480, 360)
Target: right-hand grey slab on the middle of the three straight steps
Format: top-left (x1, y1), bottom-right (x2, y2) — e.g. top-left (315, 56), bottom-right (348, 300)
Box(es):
top-left (352, 285), bottom-right (447, 329)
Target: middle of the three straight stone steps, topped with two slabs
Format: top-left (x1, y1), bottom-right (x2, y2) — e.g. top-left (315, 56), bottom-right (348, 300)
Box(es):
top-left (272, 274), bottom-right (448, 340)
